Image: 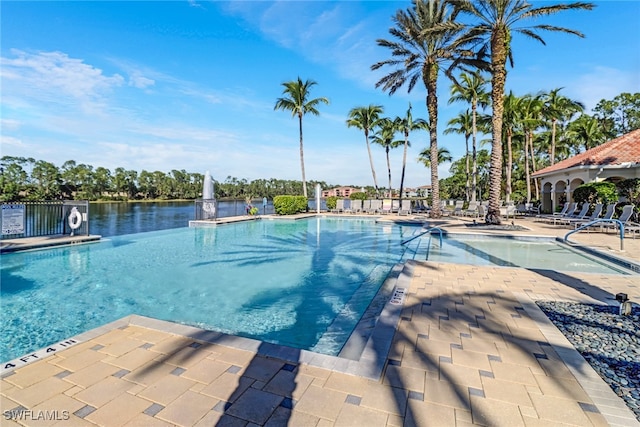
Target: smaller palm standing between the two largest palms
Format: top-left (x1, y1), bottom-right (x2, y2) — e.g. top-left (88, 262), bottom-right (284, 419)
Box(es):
top-left (449, 71), bottom-right (489, 202)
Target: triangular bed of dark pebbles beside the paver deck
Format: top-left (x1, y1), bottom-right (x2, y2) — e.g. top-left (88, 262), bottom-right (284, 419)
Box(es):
top-left (537, 301), bottom-right (640, 421)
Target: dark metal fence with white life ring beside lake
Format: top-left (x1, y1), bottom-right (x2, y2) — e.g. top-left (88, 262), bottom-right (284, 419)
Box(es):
top-left (0, 200), bottom-right (89, 240)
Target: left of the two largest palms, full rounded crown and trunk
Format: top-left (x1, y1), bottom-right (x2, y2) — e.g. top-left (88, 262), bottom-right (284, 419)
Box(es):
top-left (371, 0), bottom-right (480, 217)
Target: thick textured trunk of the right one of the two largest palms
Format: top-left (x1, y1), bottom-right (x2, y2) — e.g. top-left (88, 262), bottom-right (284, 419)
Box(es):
top-left (486, 28), bottom-right (508, 224)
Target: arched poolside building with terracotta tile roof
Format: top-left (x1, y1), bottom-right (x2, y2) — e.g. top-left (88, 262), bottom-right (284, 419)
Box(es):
top-left (533, 129), bottom-right (640, 212)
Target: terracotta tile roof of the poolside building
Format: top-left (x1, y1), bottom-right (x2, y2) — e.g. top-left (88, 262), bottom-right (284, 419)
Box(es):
top-left (533, 129), bottom-right (640, 176)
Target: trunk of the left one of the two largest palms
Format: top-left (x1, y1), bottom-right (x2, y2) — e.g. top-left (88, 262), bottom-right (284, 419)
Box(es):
top-left (422, 64), bottom-right (442, 218)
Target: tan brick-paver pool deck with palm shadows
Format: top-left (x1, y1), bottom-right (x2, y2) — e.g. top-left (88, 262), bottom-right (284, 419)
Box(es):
top-left (0, 214), bottom-right (640, 427)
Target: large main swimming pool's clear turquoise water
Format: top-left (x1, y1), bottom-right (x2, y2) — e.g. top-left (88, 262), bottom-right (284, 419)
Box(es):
top-left (0, 218), bottom-right (415, 361)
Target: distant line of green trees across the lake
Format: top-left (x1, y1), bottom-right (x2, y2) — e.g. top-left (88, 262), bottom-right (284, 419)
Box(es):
top-left (0, 156), bottom-right (338, 202)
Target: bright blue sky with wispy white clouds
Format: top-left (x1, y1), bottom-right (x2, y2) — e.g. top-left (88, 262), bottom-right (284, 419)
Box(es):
top-left (0, 0), bottom-right (640, 187)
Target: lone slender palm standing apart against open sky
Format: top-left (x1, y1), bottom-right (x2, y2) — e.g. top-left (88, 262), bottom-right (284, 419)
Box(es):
top-left (273, 77), bottom-right (329, 198)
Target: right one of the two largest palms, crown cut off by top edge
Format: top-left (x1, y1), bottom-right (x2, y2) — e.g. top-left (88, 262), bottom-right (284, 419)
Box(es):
top-left (450, 0), bottom-right (594, 224)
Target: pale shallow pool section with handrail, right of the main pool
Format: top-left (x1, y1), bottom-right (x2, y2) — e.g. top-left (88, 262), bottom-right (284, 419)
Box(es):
top-left (414, 233), bottom-right (627, 274)
